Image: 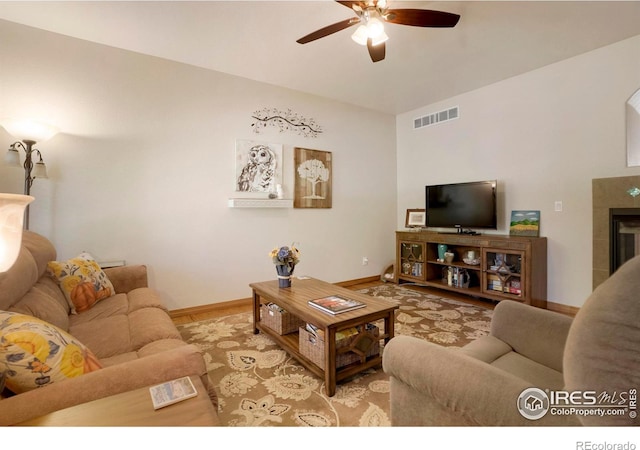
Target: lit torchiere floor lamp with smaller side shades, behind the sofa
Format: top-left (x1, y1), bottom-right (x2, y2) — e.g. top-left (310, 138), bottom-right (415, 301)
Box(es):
top-left (0, 119), bottom-right (58, 230)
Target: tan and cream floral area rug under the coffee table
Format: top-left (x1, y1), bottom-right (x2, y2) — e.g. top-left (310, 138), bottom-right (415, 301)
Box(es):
top-left (178, 284), bottom-right (493, 427)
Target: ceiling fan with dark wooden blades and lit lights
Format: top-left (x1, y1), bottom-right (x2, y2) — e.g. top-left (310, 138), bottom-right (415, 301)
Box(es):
top-left (296, 0), bottom-right (460, 62)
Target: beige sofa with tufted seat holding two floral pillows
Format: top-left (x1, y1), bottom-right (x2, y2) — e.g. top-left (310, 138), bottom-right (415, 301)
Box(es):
top-left (0, 231), bottom-right (217, 425)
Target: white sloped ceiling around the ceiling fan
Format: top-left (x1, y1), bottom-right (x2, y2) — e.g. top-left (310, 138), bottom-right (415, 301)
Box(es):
top-left (0, 0), bottom-right (640, 114)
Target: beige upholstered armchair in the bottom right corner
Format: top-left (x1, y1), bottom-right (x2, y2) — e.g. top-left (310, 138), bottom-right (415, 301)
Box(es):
top-left (383, 253), bottom-right (640, 426)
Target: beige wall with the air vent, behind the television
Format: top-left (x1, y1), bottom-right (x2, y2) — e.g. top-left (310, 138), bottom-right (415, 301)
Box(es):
top-left (396, 36), bottom-right (640, 306)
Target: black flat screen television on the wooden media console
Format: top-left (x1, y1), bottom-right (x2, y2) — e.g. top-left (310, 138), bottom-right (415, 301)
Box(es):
top-left (425, 180), bottom-right (498, 233)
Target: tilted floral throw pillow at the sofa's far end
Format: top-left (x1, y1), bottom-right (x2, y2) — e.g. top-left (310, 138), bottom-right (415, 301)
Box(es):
top-left (47, 252), bottom-right (115, 313)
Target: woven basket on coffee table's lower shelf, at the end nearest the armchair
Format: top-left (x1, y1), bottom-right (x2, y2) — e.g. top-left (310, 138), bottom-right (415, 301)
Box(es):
top-left (299, 324), bottom-right (380, 370)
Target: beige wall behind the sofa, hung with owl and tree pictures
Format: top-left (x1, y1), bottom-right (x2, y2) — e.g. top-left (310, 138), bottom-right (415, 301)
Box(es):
top-left (0, 21), bottom-right (397, 309)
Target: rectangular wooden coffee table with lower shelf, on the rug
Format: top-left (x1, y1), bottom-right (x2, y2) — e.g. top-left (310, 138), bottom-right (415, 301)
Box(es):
top-left (249, 278), bottom-right (398, 397)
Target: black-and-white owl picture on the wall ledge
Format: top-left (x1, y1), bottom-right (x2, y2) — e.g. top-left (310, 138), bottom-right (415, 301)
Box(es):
top-left (235, 139), bottom-right (283, 194)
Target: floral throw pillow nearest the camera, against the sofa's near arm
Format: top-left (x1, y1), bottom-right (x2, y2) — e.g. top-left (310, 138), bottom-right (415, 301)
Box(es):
top-left (0, 311), bottom-right (102, 394)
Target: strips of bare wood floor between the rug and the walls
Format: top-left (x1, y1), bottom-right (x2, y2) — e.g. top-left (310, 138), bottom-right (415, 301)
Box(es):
top-left (171, 277), bottom-right (497, 325)
